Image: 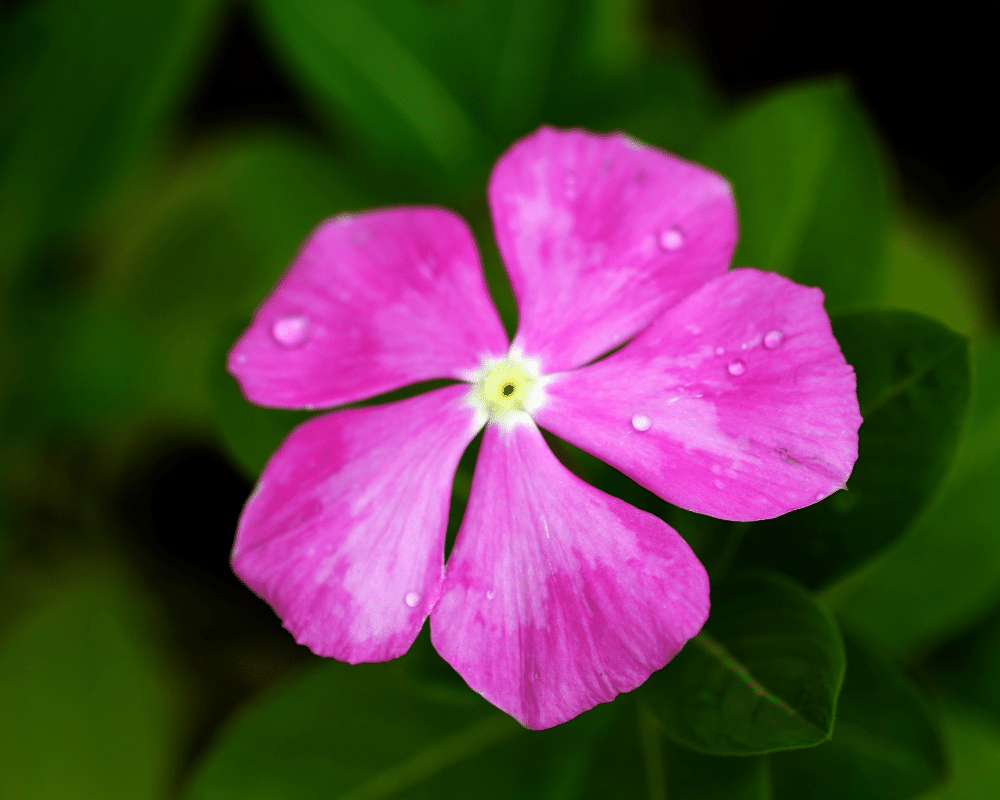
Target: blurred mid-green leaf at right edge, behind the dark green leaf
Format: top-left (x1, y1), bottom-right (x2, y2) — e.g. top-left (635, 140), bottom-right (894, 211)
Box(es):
top-left (832, 342), bottom-right (1000, 653)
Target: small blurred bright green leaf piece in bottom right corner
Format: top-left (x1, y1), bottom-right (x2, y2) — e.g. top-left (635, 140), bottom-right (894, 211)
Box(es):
top-left (920, 705), bottom-right (1000, 800)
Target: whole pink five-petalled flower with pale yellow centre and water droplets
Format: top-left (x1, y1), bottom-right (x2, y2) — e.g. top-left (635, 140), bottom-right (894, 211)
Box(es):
top-left (229, 128), bottom-right (861, 728)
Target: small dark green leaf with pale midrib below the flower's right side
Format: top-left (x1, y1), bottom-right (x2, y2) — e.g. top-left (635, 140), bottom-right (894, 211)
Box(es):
top-left (641, 573), bottom-right (844, 755)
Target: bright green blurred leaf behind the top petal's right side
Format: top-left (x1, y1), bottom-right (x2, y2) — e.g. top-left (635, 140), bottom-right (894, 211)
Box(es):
top-left (699, 80), bottom-right (889, 309)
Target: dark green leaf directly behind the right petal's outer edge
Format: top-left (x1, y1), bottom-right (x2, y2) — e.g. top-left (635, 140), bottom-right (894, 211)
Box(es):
top-left (737, 311), bottom-right (969, 587)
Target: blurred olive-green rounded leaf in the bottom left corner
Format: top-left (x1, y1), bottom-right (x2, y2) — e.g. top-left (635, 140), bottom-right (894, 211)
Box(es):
top-left (0, 585), bottom-right (174, 800)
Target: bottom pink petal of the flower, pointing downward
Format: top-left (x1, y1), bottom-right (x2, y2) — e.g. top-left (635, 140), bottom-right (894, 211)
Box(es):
top-left (431, 423), bottom-right (709, 729)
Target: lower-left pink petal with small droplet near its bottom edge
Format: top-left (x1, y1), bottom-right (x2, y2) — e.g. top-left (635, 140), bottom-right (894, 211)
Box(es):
top-left (233, 386), bottom-right (480, 664)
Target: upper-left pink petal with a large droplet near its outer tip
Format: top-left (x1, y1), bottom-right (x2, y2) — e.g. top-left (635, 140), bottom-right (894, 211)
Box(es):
top-left (229, 208), bottom-right (508, 408)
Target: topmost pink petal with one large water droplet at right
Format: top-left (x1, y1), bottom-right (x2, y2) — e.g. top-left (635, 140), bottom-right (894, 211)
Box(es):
top-left (489, 127), bottom-right (737, 372)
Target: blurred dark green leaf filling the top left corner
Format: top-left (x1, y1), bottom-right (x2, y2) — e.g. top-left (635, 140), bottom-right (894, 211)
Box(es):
top-left (0, 0), bottom-right (221, 284)
